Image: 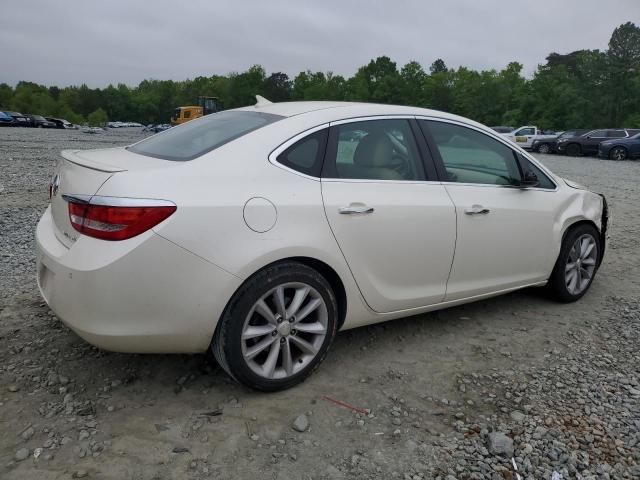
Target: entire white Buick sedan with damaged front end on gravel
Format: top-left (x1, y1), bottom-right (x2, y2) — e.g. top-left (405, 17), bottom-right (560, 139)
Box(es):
top-left (36, 99), bottom-right (608, 391)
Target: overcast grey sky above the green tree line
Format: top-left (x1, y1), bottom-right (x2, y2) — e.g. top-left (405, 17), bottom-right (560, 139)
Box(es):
top-left (0, 0), bottom-right (640, 87)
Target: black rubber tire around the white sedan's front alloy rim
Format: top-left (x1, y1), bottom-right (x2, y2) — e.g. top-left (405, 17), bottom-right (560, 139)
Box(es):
top-left (547, 223), bottom-right (602, 303)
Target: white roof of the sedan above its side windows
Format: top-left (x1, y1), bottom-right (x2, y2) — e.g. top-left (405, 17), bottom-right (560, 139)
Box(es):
top-left (236, 102), bottom-right (488, 129)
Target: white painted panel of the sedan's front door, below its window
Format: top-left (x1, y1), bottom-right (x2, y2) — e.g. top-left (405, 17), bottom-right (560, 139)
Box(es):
top-left (446, 183), bottom-right (556, 300)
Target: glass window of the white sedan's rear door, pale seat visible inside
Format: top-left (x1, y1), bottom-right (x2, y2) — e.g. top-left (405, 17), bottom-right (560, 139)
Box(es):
top-left (324, 119), bottom-right (425, 180)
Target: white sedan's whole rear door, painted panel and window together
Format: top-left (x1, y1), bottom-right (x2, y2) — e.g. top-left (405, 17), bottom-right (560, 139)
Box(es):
top-left (322, 118), bottom-right (456, 312)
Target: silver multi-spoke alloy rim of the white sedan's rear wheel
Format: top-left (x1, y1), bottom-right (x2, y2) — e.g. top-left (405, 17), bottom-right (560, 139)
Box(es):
top-left (242, 282), bottom-right (328, 379)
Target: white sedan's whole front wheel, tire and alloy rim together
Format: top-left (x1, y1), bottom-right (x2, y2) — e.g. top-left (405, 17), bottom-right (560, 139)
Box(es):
top-left (548, 224), bottom-right (602, 302)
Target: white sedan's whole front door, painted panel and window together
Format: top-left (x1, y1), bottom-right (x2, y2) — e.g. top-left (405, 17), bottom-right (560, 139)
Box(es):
top-left (420, 121), bottom-right (556, 301)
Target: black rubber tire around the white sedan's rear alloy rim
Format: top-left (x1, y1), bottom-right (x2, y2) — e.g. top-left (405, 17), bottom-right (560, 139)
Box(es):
top-left (210, 261), bottom-right (339, 392)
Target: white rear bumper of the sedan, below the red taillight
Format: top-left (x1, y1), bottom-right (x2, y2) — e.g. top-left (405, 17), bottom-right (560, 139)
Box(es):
top-left (36, 208), bottom-right (242, 353)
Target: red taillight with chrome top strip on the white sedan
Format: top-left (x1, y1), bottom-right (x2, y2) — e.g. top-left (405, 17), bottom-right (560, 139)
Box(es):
top-left (64, 195), bottom-right (176, 240)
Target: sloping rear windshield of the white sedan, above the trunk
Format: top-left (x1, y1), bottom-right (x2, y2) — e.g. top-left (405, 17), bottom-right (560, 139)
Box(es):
top-left (128, 111), bottom-right (284, 162)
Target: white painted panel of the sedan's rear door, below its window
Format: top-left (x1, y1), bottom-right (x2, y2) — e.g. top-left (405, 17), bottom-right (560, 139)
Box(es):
top-left (322, 180), bottom-right (456, 312)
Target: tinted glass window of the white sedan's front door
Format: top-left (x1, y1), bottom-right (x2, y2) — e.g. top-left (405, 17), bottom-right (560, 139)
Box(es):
top-left (421, 121), bottom-right (521, 185)
